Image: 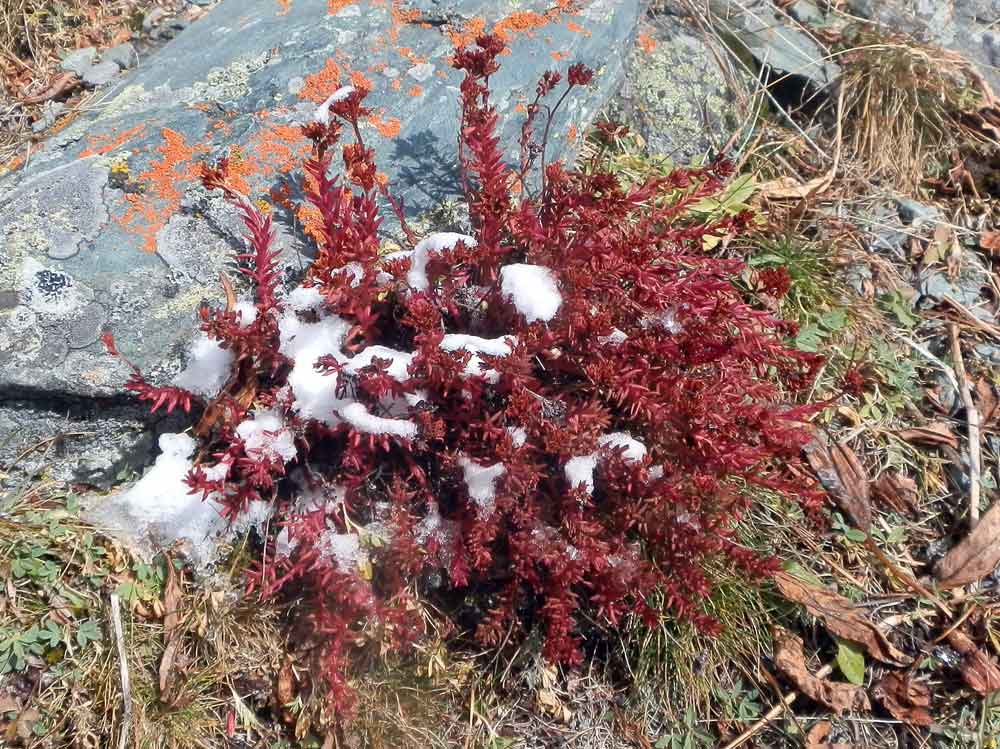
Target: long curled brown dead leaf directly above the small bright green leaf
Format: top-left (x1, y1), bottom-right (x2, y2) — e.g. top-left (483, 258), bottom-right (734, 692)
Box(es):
top-left (774, 572), bottom-right (912, 666)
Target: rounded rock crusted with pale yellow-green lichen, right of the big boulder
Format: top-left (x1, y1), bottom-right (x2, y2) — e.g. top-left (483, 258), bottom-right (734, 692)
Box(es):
top-left (610, 15), bottom-right (736, 164)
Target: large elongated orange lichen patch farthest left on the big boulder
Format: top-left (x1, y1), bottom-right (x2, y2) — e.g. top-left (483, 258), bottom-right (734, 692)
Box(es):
top-left (118, 128), bottom-right (208, 252)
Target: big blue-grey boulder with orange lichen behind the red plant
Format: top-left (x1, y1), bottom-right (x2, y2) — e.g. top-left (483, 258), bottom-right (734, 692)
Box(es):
top-left (0, 0), bottom-right (641, 484)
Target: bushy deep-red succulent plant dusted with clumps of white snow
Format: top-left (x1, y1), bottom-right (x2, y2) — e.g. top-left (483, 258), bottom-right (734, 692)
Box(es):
top-left (101, 36), bottom-right (819, 708)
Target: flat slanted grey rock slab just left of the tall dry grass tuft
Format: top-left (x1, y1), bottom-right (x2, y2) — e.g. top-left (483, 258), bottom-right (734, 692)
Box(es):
top-left (708, 0), bottom-right (840, 88)
